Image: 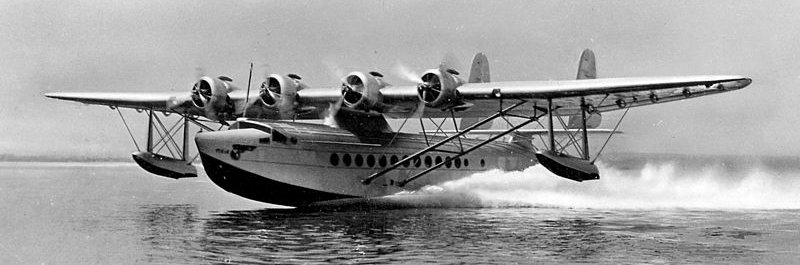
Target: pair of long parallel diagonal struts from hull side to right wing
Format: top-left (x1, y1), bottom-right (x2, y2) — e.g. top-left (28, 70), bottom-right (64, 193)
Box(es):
top-left (361, 100), bottom-right (544, 187)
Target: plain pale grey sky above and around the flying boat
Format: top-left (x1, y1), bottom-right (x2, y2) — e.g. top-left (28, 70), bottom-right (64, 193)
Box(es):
top-left (0, 0), bottom-right (800, 158)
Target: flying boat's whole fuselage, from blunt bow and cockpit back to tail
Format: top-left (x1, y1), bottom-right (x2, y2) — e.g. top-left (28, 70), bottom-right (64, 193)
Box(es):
top-left (195, 118), bottom-right (536, 206)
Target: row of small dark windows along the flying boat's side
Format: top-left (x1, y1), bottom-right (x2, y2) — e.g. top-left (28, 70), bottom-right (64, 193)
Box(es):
top-left (330, 153), bottom-right (486, 168)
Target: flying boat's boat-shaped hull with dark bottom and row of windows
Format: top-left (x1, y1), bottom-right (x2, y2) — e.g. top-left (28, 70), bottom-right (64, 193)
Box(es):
top-left (195, 121), bottom-right (535, 206)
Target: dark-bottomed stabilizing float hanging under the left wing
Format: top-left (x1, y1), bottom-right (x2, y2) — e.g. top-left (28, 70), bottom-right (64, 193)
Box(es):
top-left (131, 152), bottom-right (197, 179)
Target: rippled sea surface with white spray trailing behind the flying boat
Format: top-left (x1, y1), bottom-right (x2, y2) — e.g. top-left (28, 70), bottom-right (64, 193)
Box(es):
top-left (0, 155), bottom-right (800, 264)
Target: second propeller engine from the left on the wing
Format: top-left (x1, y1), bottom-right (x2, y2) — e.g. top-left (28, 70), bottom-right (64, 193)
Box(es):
top-left (258, 74), bottom-right (306, 119)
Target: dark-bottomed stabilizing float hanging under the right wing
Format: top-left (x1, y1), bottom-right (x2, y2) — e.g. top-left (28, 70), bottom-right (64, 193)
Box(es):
top-left (536, 150), bottom-right (600, 182)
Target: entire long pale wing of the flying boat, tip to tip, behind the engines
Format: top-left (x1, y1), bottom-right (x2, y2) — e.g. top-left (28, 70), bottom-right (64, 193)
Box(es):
top-left (45, 76), bottom-right (751, 119)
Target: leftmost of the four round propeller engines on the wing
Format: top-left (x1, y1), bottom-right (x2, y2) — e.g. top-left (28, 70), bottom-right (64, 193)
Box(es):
top-left (191, 76), bottom-right (236, 121)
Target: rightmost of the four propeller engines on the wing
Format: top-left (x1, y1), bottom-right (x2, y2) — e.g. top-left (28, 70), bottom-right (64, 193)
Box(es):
top-left (417, 68), bottom-right (464, 109)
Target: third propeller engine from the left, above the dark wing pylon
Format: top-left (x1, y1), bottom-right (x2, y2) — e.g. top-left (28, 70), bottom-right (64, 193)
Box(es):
top-left (342, 72), bottom-right (388, 112)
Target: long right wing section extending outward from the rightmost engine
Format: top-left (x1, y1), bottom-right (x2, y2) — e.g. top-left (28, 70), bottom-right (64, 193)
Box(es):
top-left (450, 76), bottom-right (752, 116)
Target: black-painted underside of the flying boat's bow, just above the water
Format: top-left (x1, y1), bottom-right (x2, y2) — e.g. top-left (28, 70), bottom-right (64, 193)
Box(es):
top-left (200, 153), bottom-right (356, 206)
